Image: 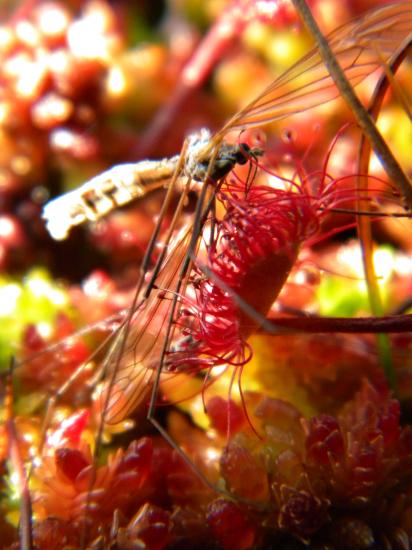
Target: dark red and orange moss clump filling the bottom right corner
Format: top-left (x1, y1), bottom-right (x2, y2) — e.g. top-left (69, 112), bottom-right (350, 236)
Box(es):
top-left (211, 382), bottom-right (412, 548)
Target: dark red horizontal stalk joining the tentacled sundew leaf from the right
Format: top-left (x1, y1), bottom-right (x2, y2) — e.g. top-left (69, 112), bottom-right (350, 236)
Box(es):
top-left (264, 315), bottom-right (412, 334)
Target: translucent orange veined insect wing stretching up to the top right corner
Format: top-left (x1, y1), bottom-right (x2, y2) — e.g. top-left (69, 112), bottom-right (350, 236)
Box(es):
top-left (215, 2), bottom-right (412, 140)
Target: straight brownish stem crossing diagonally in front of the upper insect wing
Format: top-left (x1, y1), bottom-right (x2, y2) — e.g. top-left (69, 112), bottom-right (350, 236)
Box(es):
top-left (292, 0), bottom-right (412, 210)
